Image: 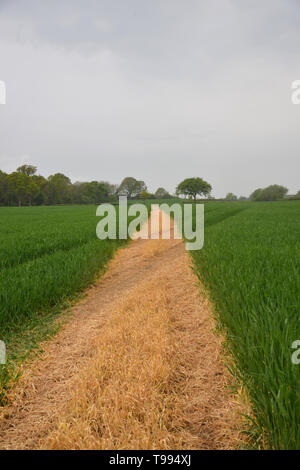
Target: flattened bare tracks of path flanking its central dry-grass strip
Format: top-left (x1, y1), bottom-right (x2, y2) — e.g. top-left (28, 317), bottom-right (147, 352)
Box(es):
top-left (0, 214), bottom-right (244, 449)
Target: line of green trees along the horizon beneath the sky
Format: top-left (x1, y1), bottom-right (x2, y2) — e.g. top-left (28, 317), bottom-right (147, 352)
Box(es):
top-left (0, 164), bottom-right (300, 206)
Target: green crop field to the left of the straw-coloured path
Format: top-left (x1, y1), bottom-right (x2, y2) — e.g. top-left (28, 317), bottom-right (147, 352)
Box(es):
top-left (0, 206), bottom-right (124, 398)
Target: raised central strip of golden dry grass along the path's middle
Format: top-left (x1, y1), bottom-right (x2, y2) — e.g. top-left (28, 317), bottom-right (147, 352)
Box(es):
top-left (45, 275), bottom-right (188, 449)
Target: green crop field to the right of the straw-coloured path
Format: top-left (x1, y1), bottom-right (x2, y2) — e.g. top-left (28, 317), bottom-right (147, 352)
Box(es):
top-left (191, 201), bottom-right (300, 449)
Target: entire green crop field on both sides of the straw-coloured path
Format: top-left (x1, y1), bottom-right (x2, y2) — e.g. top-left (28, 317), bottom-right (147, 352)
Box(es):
top-left (0, 200), bottom-right (300, 449)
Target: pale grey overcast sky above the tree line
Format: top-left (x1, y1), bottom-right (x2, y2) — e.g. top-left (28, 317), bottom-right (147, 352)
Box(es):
top-left (0, 0), bottom-right (300, 197)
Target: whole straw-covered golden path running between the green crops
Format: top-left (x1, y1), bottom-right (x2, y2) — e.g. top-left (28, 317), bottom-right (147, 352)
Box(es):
top-left (0, 212), bottom-right (241, 450)
